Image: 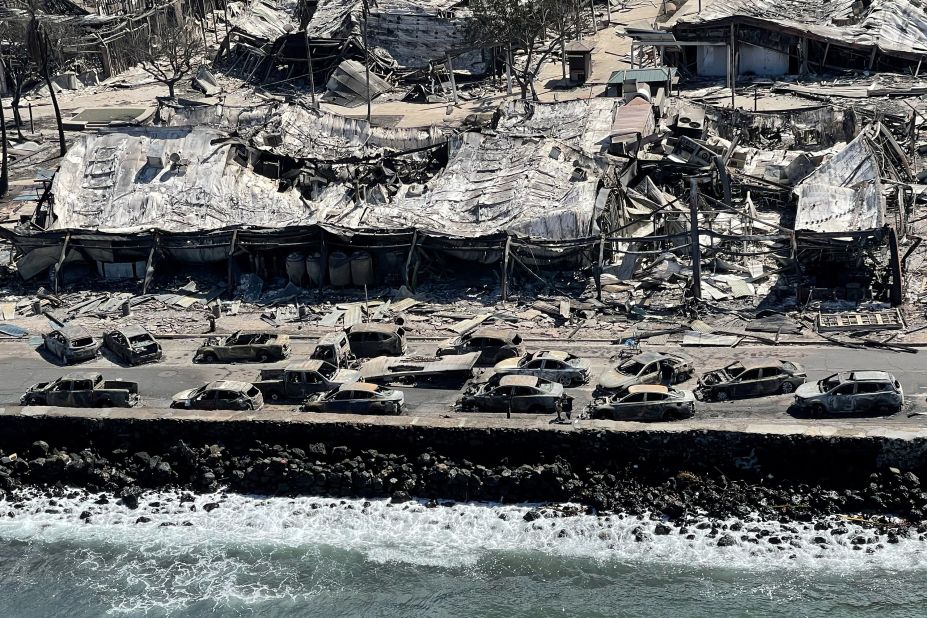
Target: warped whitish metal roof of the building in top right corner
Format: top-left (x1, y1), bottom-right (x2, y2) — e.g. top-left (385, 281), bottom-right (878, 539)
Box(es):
top-left (677, 0), bottom-right (927, 58)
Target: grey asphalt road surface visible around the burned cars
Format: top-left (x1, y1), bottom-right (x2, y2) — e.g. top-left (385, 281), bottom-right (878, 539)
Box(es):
top-left (0, 338), bottom-right (927, 423)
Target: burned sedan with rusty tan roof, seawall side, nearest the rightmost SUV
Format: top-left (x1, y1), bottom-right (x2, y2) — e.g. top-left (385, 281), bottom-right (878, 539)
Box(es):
top-left (589, 384), bottom-right (695, 421)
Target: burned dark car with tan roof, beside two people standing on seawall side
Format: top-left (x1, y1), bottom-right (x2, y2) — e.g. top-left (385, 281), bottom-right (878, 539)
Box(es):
top-left (458, 376), bottom-right (573, 415)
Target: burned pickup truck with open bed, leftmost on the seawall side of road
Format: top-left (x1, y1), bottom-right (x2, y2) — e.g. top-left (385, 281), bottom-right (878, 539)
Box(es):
top-left (20, 373), bottom-right (139, 408)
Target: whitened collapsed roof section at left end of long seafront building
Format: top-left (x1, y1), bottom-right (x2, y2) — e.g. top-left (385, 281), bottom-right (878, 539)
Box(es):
top-left (48, 127), bottom-right (343, 231)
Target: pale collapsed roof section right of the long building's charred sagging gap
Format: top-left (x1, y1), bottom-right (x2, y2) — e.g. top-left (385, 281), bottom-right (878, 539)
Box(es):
top-left (337, 133), bottom-right (604, 240)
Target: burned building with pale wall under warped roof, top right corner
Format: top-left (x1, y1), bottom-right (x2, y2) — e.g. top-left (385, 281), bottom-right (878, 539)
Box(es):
top-left (667, 0), bottom-right (927, 76)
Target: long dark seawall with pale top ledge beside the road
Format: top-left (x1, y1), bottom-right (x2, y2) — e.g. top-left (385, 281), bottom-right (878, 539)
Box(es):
top-left (0, 408), bottom-right (927, 484)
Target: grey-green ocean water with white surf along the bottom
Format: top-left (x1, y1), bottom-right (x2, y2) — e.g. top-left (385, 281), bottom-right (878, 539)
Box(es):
top-left (0, 493), bottom-right (927, 617)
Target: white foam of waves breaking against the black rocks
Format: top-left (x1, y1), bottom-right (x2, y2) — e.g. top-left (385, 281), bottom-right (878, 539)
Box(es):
top-left (0, 486), bottom-right (927, 612)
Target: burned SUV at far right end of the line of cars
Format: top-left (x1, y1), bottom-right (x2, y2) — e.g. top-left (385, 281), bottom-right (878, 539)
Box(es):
top-left (795, 371), bottom-right (904, 416)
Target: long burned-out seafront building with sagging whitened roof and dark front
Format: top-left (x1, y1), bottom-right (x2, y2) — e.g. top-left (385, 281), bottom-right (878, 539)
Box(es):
top-left (0, 101), bottom-right (618, 294)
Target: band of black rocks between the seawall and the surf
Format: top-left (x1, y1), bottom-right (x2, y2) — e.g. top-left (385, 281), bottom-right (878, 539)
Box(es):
top-left (0, 441), bottom-right (927, 546)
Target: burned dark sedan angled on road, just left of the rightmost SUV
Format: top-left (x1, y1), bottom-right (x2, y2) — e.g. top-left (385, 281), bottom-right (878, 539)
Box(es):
top-left (696, 360), bottom-right (807, 401)
